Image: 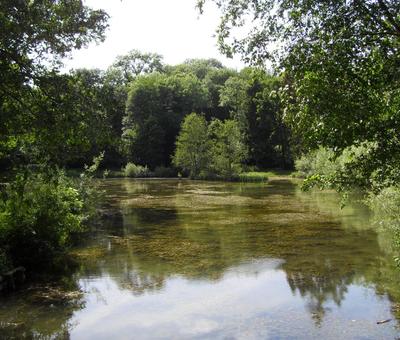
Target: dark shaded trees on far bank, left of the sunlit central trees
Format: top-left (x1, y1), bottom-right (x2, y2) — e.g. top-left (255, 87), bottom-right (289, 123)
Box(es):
top-left (16, 70), bottom-right (124, 167)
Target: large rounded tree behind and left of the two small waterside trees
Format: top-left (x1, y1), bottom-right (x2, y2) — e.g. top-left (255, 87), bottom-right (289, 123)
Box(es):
top-left (123, 73), bottom-right (207, 168)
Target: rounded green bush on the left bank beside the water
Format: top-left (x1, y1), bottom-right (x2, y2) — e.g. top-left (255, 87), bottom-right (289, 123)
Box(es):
top-left (0, 171), bottom-right (90, 268)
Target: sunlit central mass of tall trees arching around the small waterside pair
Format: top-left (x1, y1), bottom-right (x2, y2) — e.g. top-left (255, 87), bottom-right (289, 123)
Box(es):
top-left (122, 59), bottom-right (291, 176)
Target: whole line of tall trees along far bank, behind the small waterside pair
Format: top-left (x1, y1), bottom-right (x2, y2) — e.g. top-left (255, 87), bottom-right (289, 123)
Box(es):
top-left (2, 55), bottom-right (291, 173)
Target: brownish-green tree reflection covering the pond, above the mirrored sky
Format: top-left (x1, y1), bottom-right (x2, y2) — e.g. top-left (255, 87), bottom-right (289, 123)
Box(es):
top-left (0, 180), bottom-right (400, 336)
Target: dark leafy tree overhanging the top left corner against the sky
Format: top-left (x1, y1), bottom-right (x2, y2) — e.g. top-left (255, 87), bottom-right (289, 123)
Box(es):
top-left (0, 0), bottom-right (108, 167)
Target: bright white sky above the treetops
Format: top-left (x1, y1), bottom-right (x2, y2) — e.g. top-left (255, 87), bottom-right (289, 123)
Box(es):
top-left (64, 0), bottom-right (244, 70)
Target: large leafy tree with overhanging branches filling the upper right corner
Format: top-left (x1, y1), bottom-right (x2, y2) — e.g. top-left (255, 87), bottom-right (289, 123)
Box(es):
top-left (202, 0), bottom-right (400, 187)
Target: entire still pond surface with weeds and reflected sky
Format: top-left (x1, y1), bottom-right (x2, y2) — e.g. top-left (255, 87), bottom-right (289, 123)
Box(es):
top-left (0, 178), bottom-right (400, 339)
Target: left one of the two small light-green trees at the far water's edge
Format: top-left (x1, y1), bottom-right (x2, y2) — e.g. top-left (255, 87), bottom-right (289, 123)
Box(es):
top-left (173, 113), bottom-right (211, 178)
